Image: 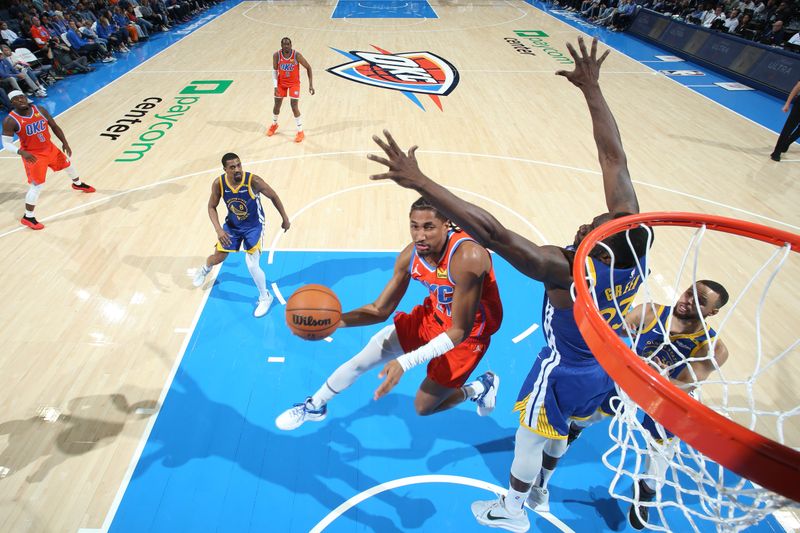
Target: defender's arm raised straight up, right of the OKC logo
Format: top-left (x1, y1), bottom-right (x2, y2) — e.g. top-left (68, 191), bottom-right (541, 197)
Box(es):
top-left (556, 37), bottom-right (639, 213)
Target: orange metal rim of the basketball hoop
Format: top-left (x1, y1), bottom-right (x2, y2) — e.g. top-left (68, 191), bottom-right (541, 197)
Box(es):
top-left (573, 212), bottom-right (800, 501)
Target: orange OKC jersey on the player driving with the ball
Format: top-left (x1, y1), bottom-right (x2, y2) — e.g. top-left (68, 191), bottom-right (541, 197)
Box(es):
top-left (409, 231), bottom-right (503, 337)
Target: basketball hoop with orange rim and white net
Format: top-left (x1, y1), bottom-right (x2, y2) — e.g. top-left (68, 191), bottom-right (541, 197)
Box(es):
top-left (573, 212), bottom-right (800, 530)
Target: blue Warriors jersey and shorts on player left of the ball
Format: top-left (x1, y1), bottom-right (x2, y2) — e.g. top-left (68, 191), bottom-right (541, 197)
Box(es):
top-left (217, 172), bottom-right (264, 252)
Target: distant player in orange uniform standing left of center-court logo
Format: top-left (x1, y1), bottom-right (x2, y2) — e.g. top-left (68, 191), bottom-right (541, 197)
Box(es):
top-left (267, 37), bottom-right (314, 143)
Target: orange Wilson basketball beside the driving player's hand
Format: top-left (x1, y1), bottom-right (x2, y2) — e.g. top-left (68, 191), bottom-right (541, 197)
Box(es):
top-left (286, 285), bottom-right (342, 341)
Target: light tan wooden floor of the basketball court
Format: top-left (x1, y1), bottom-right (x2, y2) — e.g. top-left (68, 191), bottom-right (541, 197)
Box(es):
top-left (0, 0), bottom-right (800, 532)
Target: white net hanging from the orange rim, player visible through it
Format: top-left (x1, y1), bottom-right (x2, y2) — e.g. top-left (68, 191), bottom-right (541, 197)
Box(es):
top-left (587, 217), bottom-right (800, 531)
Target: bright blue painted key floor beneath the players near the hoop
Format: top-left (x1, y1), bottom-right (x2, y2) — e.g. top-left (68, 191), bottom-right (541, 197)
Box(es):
top-left (111, 252), bottom-right (773, 533)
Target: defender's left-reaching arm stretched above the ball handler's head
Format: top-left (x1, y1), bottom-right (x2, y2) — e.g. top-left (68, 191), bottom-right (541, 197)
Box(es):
top-left (367, 130), bottom-right (572, 288)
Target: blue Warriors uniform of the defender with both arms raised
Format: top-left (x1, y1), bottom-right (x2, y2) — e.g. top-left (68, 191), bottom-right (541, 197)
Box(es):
top-left (514, 247), bottom-right (647, 439)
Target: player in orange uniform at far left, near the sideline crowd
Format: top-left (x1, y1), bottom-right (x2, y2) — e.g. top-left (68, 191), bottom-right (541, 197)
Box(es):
top-left (3, 91), bottom-right (95, 230)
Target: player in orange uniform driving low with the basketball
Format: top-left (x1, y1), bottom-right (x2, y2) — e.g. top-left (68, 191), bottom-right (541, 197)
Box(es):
top-left (275, 198), bottom-right (503, 430)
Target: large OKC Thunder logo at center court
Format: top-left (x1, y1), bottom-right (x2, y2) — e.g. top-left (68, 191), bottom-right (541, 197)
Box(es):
top-left (328, 45), bottom-right (459, 110)
